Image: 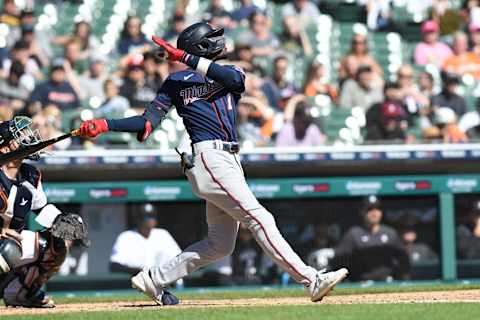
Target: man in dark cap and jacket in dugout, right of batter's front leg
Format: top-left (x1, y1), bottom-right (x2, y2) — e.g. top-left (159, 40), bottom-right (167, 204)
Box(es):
top-left (334, 196), bottom-right (410, 281)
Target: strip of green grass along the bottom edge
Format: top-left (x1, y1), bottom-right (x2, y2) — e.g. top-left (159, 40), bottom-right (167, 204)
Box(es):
top-left (5, 303), bottom-right (480, 320)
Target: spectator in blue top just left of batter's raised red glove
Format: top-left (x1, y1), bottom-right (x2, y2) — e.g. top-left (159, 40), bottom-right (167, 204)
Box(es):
top-left (117, 16), bottom-right (148, 56)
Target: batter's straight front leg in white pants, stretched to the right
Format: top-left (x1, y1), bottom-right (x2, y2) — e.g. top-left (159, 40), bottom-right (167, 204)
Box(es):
top-left (196, 150), bottom-right (347, 300)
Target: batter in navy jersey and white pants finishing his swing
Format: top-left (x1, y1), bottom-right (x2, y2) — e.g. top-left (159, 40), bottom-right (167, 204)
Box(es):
top-left (80, 22), bottom-right (348, 304)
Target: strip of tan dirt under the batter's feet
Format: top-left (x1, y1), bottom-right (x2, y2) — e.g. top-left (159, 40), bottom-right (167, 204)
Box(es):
top-left (0, 290), bottom-right (480, 315)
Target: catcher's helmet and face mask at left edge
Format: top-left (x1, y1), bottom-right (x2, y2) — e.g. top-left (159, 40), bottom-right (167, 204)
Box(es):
top-left (0, 116), bottom-right (42, 161)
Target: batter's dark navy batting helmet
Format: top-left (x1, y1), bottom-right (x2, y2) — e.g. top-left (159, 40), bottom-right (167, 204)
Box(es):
top-left (177, 22), bottom-right (225, 59)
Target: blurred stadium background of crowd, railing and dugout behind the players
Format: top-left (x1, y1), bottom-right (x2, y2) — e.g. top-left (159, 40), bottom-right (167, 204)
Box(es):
top-left (0, 0), bottom-right (480, 290)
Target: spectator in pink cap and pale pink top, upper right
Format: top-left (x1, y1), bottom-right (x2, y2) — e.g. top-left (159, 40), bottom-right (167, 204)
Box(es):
top-left (413, 20), bottom-right (452, 68)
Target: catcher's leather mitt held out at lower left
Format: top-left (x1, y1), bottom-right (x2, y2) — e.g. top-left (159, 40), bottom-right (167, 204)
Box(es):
top-left (51, 213), bottom-right (90, 247)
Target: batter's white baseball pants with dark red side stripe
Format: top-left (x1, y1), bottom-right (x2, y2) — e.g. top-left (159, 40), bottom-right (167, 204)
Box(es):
top-left (150, 141), bottom-right (317, 287)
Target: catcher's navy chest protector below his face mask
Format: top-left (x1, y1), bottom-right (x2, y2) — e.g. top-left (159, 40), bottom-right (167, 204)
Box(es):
top-left (0, 164), bottom-right (46, 232)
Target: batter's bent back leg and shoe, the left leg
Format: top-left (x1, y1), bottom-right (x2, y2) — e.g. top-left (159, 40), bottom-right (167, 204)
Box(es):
top-left (132, 201), bottom-right (239, 304)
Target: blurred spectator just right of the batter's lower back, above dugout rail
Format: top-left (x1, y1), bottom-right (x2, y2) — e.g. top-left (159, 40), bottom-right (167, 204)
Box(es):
top-left (237, 96), bottom-right (273, 147)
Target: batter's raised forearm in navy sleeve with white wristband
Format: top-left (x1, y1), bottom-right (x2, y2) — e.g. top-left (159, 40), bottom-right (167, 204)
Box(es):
top-left (185, 54), bottom-right (245, 93)
